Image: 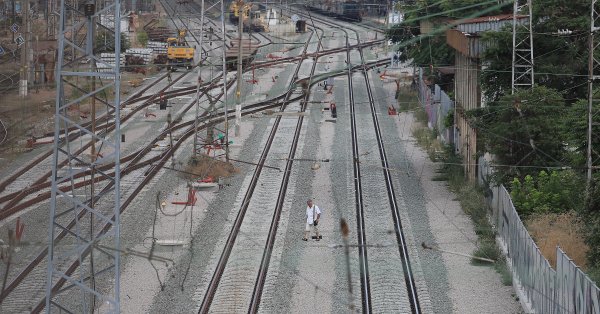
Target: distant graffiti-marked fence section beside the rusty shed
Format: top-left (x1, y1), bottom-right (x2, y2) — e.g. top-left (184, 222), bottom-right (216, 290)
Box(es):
top-left (417, 69), bottom-right (454, 144)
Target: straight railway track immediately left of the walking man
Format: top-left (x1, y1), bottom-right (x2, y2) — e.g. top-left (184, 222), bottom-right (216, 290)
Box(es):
top-left (198, 21), bottom-right (316, 313)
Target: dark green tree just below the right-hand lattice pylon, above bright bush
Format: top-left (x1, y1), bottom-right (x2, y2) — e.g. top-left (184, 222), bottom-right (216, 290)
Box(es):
top-left (467, 86), bottom-right (566, 183)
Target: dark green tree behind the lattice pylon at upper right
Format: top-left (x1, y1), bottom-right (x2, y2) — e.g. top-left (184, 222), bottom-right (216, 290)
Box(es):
top-left (481, 0), bottom-right (590, 102)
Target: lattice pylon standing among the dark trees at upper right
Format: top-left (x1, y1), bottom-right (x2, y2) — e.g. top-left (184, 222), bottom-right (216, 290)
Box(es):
top-left (511, 0), bottom-right (533, 94)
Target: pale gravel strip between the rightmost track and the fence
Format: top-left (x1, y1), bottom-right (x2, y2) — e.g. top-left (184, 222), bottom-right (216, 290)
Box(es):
top-left (396, 113), bottom-right (522, 313)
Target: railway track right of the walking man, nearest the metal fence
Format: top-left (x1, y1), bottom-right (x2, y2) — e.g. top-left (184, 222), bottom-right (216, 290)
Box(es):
top-left (282, 6), bottom-right (421, 313)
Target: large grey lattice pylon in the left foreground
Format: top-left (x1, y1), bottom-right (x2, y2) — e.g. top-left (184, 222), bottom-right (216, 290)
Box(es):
top-left (46, 0), bottom-right (121, 313)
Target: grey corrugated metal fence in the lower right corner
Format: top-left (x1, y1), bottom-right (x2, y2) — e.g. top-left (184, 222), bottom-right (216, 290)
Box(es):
top-left (478, 158), bottom-right (600, 314)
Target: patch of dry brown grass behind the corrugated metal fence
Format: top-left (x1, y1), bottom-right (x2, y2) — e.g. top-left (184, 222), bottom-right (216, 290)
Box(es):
top-left (525, 213), bottom-right (588, 268)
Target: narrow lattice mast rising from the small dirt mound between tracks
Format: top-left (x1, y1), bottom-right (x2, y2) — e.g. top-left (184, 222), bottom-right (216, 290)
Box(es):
top-left (194, 0), bottom-right (229, 158)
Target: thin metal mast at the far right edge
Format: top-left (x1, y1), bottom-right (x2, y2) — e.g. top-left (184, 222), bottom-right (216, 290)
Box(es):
top-left (587, 0), bottom-right (600, 184)
